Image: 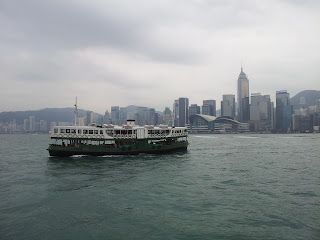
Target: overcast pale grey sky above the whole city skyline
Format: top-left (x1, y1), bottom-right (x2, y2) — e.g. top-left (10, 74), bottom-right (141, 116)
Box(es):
top-left (0, 0), bottom-right (320, 113)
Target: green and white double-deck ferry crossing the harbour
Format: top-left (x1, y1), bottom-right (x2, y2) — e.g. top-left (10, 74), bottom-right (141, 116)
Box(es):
top-left (48, 120), bottom-right (188, 157)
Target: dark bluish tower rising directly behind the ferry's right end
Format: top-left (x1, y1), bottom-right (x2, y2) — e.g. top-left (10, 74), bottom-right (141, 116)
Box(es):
top-left (174, 97), bottom-right (189, 127)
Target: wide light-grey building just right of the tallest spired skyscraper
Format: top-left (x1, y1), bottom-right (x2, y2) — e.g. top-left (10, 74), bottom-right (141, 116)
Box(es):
top-left (250, 93), bottom-right (273, 131)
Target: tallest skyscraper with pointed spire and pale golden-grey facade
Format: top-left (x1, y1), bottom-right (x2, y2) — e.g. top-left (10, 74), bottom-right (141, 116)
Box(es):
top-left (238, 67), bottom-right (250, 122)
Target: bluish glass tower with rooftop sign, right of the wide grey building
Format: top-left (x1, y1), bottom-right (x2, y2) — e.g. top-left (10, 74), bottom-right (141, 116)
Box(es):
top-left (276, 90), bottom-right (292, 132)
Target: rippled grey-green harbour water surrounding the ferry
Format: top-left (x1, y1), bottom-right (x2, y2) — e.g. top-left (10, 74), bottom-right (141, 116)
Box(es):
top-left (0, 134), bottom-right (320, 240)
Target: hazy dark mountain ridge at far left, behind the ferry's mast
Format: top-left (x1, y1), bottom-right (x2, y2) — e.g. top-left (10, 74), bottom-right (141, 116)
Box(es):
top-left (0, 108), bottom-right (99, 124)
